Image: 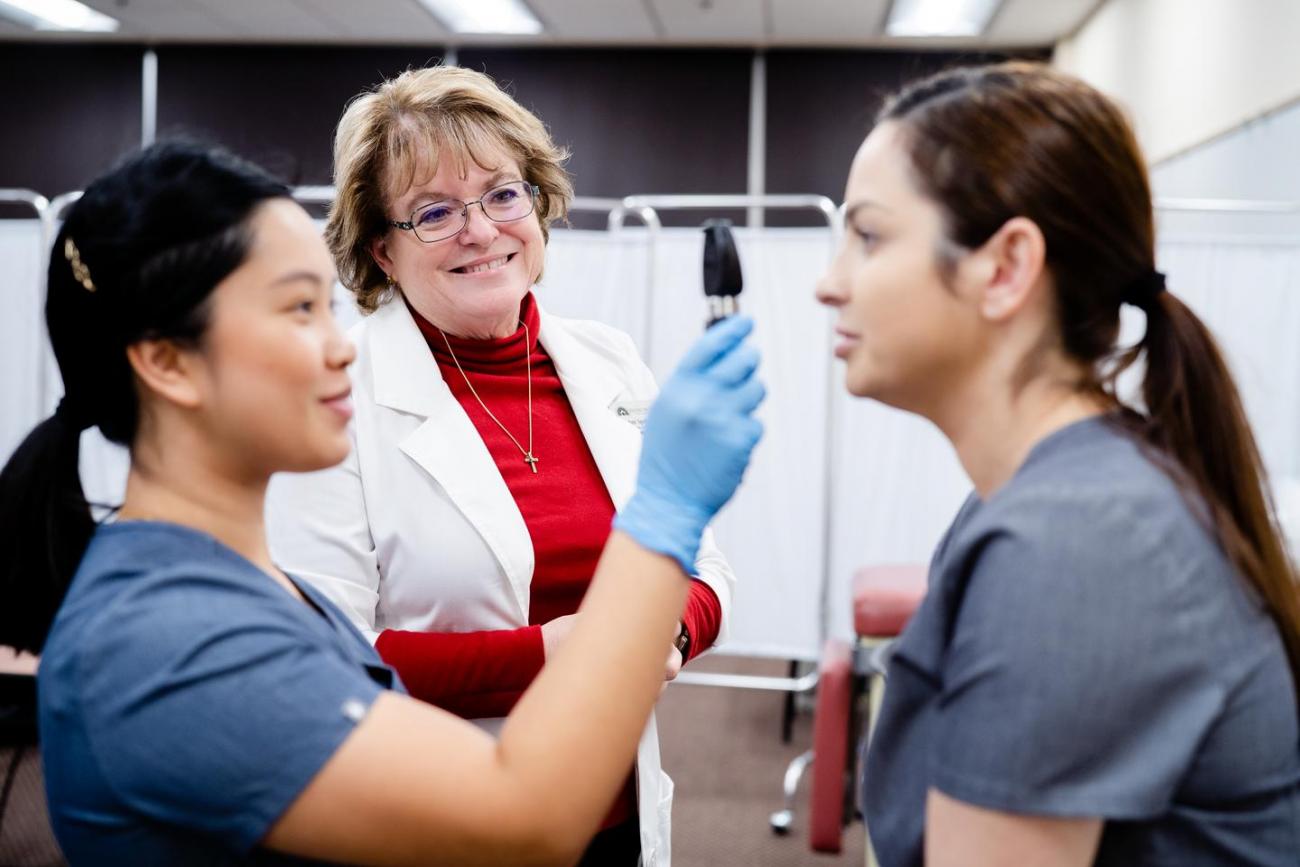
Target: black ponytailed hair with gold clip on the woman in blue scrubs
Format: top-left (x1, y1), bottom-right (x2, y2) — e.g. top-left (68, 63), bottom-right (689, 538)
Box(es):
top-left (0, 142), bottom-right (289, 653)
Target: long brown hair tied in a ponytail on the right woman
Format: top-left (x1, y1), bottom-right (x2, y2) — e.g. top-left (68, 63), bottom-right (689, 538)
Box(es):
top-left (878, 62), bottom-right (1300, 701)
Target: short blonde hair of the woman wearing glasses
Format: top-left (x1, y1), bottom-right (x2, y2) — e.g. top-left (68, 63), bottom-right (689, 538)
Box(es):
top-left (325, 66), bottom-right (573, 312)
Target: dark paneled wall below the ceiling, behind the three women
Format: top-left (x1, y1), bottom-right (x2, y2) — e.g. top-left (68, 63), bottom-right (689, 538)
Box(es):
top-left (0, 43), bottom-right (1041, 225)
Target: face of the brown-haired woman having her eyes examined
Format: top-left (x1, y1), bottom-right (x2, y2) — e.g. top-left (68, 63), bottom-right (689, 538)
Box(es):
top-left (818, 122), bottom-right (980, 417)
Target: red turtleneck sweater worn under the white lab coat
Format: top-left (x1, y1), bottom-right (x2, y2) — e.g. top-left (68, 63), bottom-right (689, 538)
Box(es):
top-left (376, 294), bottom-right (722, 827)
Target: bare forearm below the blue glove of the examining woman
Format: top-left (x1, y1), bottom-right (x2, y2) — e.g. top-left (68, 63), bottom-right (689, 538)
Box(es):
top-left (498, 532), bottom-right (688, 832)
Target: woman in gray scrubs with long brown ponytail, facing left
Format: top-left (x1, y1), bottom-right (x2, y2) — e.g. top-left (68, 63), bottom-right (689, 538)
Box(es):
top-left (818, 64), bottom-right (1300, 867)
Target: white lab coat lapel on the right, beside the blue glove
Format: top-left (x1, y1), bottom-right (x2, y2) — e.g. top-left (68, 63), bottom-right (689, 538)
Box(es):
top-left (538, 311), bottom-right (641, 510)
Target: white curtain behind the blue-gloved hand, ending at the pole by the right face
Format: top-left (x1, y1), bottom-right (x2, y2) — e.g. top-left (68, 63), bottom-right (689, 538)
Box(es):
top-left (551, 229), bottom-right (831, 659)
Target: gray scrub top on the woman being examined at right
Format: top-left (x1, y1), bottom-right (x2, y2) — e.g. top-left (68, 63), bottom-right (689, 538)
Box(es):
top-left (862, 417), bottom-right (1300, 867)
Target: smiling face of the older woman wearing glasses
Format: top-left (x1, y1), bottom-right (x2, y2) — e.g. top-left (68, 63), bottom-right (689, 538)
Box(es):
top-left (371, 146), bottom-right (546, 338)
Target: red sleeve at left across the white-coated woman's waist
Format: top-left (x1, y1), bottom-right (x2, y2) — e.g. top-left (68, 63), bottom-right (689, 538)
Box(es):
top-left (374, 627), bottom-right (546, 719)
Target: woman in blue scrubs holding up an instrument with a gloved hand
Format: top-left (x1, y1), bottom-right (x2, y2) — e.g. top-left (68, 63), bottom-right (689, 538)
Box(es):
top-left (0, 144), bottom-right (763, 867)
